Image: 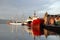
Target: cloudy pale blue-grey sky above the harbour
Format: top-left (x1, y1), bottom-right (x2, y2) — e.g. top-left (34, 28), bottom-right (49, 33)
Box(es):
top-left (0, 0), bottom-right (60, 19)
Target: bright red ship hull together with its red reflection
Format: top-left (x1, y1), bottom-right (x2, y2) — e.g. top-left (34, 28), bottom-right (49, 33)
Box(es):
top-left (31, 18), bottom-right (43, 36)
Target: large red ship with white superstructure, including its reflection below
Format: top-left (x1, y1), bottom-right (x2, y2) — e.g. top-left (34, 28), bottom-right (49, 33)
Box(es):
top-left (23, 12), bottom-right (44, 39)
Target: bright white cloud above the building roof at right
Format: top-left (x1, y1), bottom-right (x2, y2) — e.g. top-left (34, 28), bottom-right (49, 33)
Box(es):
top-left (47, 1), bottom-right (60, 15)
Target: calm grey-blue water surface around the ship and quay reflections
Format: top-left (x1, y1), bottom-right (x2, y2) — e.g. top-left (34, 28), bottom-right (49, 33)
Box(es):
top-left (0, 24), bottom-right (60, 40)
